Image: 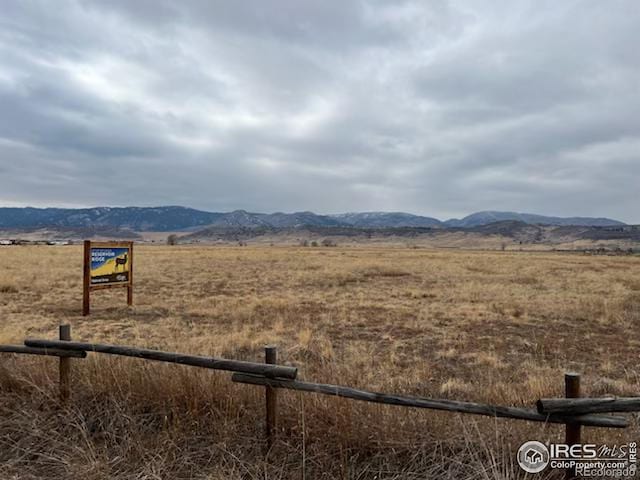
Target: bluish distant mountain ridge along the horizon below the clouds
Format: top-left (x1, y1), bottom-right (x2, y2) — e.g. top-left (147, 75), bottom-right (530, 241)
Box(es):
top-left (0, 206), bottom-right (625, 232)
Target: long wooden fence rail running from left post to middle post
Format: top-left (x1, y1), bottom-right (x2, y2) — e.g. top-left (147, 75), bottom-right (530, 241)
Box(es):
top-left (24, 339), bottom-right (298, 379)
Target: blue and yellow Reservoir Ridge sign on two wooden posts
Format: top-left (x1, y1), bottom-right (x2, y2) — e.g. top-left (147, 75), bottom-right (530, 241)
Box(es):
top-left (82, 240), bottom-right (133, 316)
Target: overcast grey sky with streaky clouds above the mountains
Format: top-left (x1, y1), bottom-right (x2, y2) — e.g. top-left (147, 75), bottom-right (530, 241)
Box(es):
top-left (0, 0), bottom-right (640, 223)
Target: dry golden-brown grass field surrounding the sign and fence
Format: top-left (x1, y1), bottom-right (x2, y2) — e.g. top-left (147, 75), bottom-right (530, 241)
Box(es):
top-left (0, 246), bottom-right (640, 479)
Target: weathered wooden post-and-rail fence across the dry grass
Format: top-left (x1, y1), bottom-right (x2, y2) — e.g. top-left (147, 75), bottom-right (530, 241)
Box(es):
top-left (0, 325), bottom-right (640, 478)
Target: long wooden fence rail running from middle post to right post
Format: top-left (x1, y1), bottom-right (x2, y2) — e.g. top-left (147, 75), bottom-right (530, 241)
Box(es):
top-left (231, 373), bottom-right (629, 428)
